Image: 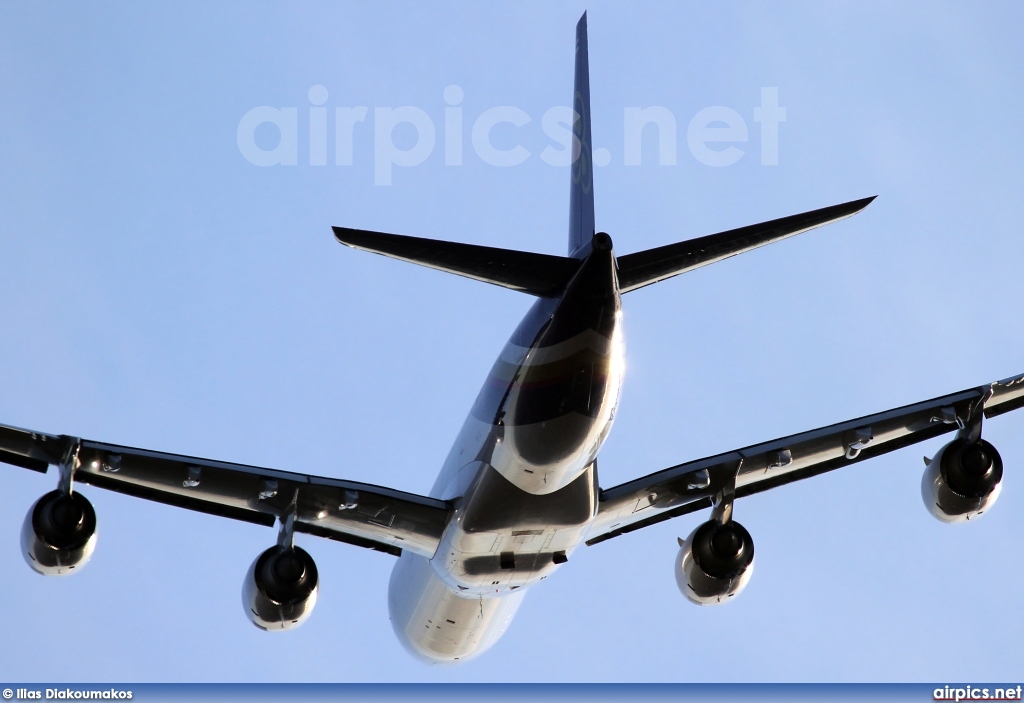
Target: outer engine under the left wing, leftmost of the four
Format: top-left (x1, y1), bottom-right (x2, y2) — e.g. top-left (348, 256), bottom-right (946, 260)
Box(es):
top-left (22, 490), bottom-right (96, 576)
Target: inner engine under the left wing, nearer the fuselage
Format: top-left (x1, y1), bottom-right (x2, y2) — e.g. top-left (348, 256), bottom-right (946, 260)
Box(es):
top-left (242, 545), bottom-right (319, 630)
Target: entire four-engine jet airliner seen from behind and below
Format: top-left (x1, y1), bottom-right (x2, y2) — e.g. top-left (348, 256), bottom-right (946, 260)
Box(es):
top-left (0, 15), bottom-right (1024, 662)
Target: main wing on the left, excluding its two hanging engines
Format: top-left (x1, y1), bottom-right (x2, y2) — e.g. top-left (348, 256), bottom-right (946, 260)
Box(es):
top-left (0, 425), bottom-right (450, 557)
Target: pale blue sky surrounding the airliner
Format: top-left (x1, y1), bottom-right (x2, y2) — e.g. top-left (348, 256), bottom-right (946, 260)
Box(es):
top-left (0, 2), bottom-right (1024, 683)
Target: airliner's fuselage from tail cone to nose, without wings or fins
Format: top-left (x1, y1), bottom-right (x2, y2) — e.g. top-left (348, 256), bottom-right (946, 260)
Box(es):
top-left (389, 241), bottom-right (624, 659)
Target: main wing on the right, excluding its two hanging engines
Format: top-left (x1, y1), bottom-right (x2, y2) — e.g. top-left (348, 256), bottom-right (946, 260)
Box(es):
top-left (587, 375), bottom-right (1024, 544)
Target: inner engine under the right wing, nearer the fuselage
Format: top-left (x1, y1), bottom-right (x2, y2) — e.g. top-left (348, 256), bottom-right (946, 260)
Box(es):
top-left (676, 520), bottom-right (754, 606)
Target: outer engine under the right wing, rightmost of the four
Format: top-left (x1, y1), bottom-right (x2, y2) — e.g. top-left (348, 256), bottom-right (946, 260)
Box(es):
top-left (921, 439), bottom-right (1002, 523)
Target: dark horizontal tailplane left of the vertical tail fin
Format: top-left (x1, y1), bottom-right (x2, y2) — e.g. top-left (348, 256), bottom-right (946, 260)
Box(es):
top-left (334, 227), bottom-right (580, 296)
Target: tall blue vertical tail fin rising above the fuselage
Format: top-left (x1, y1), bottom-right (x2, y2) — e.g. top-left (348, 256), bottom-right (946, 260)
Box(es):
top-left (568, 12), bottom-right (594, 259)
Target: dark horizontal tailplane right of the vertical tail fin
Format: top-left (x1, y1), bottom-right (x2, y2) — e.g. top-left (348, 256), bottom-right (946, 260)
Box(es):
top-left (618, 195), bottom-right (874, 293)
